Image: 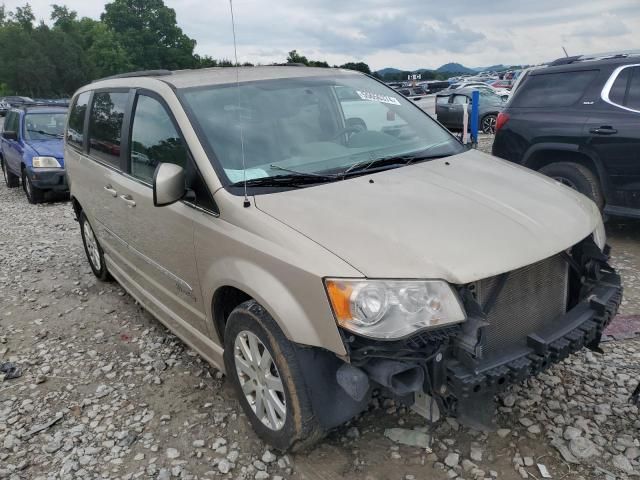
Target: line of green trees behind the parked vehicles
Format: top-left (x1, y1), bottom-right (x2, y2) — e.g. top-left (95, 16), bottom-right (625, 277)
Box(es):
top-left (0, 0), bottom-right (384, 98)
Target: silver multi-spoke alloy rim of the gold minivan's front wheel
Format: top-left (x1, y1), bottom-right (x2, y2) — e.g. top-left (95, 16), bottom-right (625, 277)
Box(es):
top-left (233, 330), bottom-right (287, 430)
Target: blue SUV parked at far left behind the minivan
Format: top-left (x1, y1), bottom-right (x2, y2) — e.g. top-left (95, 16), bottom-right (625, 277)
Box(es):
top-left (0, 105), bottom-right (69, 203)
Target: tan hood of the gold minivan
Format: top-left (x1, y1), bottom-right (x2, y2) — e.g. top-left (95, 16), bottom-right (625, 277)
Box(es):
top-left (255, 150), bottom-right (600, 284)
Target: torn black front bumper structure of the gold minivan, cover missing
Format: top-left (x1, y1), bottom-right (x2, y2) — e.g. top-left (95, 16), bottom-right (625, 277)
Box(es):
top-left (299, 237), bottom-right (622, 429)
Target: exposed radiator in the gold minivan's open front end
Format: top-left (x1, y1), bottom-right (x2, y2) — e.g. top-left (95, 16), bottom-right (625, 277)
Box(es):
top-left (474, 254), bottom-right (569, 357)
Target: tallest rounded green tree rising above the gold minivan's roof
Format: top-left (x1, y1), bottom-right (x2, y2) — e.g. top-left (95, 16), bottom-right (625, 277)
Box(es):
top-left (100, 0), bottom-right (196, 70)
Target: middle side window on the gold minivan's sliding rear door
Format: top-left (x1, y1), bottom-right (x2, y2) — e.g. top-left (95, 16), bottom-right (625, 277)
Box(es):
top-left (89, 92), bottom-right (129, 167)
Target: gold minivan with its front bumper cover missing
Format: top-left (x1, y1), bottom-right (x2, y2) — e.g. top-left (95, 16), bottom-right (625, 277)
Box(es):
top-left (65, 66), bottom-right (622, 450)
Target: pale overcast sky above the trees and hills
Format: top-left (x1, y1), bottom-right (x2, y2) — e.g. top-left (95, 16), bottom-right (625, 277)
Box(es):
top-left (5, 0), bottom-right (640, 70)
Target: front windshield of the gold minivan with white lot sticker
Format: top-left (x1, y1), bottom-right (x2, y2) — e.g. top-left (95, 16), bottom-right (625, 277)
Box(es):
top-left (180, 74), bottom-right (464, 189)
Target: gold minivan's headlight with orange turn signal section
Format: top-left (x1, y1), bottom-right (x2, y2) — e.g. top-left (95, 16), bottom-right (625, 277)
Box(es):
top-left (325, 279), bottom-right (466, 340)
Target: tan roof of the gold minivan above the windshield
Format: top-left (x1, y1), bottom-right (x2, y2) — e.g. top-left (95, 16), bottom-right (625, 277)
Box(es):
top-left (94, 66), bottom-right (359, 88)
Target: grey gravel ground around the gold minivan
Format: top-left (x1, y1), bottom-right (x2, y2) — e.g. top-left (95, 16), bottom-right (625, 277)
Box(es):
top-left (0, 146), bottom-right (640, 480)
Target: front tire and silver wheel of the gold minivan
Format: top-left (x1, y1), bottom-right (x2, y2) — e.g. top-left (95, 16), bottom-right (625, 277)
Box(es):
top-left (224, 300), bottom-right (324, 451)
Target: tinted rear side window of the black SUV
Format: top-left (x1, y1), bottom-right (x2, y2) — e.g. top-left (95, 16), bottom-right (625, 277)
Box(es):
top-left (511, 70), bottom-right (598, 107)
